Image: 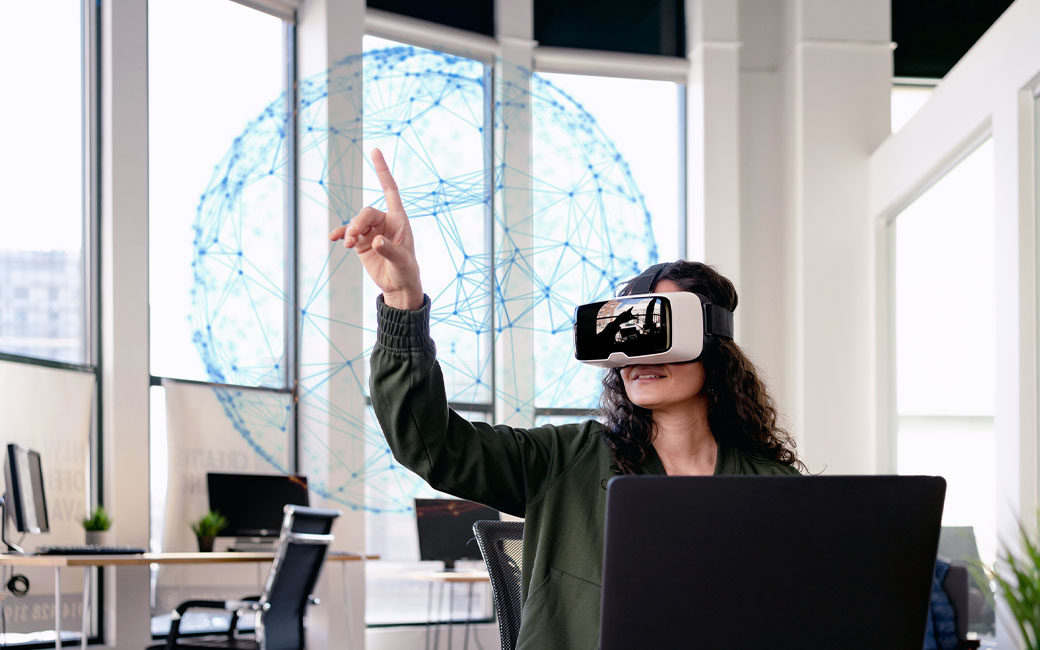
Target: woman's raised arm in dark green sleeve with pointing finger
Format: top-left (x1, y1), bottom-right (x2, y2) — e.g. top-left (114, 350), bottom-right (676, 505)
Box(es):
top-left (329, 150), bottom-right (581, 516)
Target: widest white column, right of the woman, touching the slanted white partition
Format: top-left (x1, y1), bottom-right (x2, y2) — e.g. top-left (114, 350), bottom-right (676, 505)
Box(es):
top-left (777, 0), bottom-right (892, 473)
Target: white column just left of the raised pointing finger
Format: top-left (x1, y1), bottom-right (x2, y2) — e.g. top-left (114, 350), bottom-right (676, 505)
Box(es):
top-left (296, 0), bottom-right (366, 648)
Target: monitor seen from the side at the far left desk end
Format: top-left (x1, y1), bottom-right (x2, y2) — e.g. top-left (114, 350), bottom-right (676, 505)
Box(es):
top-left (0, 443), bottom-right (51, 552)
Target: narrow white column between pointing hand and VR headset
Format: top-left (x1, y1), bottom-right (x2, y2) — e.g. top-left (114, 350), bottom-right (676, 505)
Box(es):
top-left (493, 0), bottom-right (536, 426)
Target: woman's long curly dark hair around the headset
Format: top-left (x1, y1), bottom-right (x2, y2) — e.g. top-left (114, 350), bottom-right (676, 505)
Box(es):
top-left (600, 260), bottom-right (805, 474)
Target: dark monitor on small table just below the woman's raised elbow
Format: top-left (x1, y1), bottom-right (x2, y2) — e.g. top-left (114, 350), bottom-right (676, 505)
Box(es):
top-left (415, 499), bottom-right (499, 571)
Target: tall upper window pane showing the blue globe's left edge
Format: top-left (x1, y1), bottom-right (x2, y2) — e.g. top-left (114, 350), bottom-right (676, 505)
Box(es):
top-left (148, 0), bottom-right (291, 388)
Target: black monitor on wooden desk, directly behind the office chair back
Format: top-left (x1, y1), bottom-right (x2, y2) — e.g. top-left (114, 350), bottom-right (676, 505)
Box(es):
top-left (206, 473), bottom-right (310, 538)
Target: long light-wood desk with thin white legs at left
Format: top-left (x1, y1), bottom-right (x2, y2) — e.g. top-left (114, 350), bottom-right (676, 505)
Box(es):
top-left (0, 551), bottom-right (380, 650)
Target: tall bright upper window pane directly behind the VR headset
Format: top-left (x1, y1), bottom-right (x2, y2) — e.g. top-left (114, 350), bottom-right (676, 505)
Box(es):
top-left (531, 73), bottom-right (684, 409)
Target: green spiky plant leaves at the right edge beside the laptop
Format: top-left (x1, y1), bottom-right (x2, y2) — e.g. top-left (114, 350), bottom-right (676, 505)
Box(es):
top-left (992, 511), bottom-right (1040, 650)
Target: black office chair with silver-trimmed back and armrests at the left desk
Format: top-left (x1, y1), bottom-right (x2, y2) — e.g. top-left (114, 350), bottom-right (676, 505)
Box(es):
top-left (148, 505), bottom-right (339, 650)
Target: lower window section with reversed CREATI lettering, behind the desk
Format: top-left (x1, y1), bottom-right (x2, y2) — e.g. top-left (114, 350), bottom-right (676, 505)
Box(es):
top-left (150, 380), bottom-right (294, 634)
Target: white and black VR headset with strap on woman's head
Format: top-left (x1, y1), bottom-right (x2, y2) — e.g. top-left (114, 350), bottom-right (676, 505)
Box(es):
top-left (574, 264), bottom-right (733, 368)
